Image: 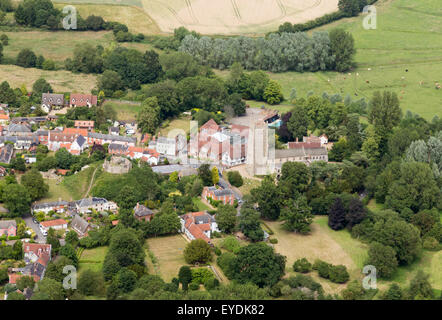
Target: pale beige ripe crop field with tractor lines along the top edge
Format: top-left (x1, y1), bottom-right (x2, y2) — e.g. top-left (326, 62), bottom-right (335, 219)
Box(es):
top-left (55, 0), bottom-right (338, 35)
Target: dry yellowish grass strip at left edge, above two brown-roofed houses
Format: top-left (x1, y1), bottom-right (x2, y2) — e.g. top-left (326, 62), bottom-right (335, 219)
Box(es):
top-left (0, 64), bottom-right (97, 93)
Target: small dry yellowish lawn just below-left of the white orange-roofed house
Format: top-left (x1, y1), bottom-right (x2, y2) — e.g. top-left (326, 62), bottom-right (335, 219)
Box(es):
top-left (146, 234), bottom-right (187, 282)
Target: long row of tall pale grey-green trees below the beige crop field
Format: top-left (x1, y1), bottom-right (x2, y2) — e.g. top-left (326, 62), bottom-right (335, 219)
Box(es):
top-left (179, 29), bottom-right (355, 72)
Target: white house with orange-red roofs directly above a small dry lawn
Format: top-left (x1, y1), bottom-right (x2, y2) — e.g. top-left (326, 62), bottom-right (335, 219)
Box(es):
top-left (180, 211), bottom-right (219, 243)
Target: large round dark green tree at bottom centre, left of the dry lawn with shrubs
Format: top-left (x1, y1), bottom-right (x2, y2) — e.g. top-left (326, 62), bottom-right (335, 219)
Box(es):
top-left (232, 242), bottom-right (286, 287)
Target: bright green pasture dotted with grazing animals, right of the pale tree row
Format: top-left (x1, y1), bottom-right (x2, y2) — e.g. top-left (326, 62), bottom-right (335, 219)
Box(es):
top-left (213, 0), bottom-right (442, 120)
